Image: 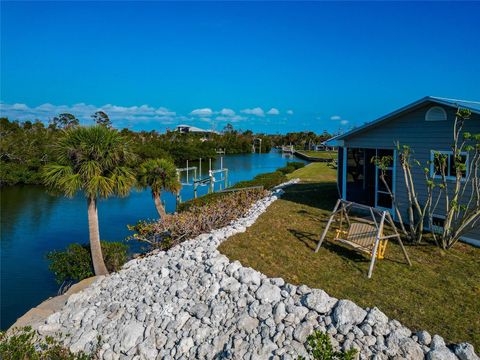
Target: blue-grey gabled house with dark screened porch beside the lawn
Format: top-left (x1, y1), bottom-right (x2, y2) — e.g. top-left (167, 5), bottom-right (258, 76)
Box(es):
top-left (335, 96), bottom-right (480, 245)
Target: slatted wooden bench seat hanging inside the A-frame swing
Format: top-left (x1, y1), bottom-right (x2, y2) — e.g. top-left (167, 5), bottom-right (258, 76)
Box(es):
top-left (333, 222), bottom-right (388, 259)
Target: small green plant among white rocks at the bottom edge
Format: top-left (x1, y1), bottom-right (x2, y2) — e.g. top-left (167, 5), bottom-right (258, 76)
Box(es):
top-left (298, 330), bottom-right (357, 360)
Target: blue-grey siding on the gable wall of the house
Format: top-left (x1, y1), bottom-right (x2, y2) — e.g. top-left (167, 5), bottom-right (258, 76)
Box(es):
top-left (339, 103), bottom-right (480, 240)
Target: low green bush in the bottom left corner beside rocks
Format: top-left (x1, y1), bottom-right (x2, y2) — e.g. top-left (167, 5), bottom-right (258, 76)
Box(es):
top-left (0, 326), bottom-right (94, 360)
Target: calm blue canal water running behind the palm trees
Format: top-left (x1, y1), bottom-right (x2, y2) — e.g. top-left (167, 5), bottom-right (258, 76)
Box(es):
top-left (0, 152), bottom-right (301, 329)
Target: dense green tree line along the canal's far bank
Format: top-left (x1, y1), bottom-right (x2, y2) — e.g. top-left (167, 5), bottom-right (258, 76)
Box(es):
top-left (0, 115), bottom-right (278, 185)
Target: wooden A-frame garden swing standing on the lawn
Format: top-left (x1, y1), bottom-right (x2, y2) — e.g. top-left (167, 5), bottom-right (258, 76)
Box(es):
top-left (315, 199), bottom-right (412, 279)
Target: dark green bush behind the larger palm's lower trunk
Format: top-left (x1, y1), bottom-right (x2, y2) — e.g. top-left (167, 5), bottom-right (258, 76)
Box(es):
top-left (47, 241), bottom-right (128, 284)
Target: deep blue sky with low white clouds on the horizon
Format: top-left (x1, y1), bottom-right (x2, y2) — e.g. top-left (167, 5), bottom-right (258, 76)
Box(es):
top-left (0, 2), bottom-right (480, 133)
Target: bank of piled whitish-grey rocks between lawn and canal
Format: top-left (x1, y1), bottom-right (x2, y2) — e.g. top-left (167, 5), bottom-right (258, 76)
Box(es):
top-left (39, 183), bottom-right (478, 360)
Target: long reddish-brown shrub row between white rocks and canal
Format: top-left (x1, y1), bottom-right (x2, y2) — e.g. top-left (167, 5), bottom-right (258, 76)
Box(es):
top-left (128, 189), bottom-right (266, 250)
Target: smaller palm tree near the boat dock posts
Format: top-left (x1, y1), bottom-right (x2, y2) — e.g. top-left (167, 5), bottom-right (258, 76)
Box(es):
top-left (138, 159), bottom-right (182, 218)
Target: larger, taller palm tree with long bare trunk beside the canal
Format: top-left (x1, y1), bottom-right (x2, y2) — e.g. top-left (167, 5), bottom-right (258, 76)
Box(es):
top-left (42, 126), bottom-right (135, 275)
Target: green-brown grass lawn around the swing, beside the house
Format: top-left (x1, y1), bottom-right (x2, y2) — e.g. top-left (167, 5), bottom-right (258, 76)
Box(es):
top-left (220, 163), bottom-right (480, 349)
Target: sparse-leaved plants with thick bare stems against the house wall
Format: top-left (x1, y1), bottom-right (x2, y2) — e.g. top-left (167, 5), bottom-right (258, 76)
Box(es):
top-left (372, 109), bottom-right (480, 250)
